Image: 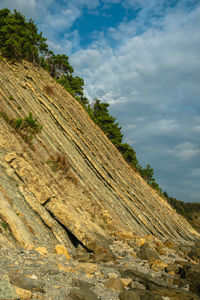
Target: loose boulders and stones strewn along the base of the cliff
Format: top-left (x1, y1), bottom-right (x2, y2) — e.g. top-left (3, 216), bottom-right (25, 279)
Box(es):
top-left (0, 235), bottom-right (200, 300)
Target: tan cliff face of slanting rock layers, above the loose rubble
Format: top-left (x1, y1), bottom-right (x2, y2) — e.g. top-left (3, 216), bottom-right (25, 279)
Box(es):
top-left (0, 61), bottom-right (198, 252)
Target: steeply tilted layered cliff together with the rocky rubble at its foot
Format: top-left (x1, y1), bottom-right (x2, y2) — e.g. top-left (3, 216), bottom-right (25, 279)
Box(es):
top-left (0, 59), bottom-right (200, 300)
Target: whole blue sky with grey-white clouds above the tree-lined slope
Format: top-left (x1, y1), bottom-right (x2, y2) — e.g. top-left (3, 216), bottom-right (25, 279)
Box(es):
top-left (0, 0), bottom-right (200, 202)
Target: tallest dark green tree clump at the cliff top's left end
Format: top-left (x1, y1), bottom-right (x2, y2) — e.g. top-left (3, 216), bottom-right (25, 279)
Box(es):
top-left (0, 8), bottom-right (48, 62)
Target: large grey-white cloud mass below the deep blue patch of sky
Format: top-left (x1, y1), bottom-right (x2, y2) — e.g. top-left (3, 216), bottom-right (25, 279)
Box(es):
top-left (72, 5), bottom-right (200, 201)
